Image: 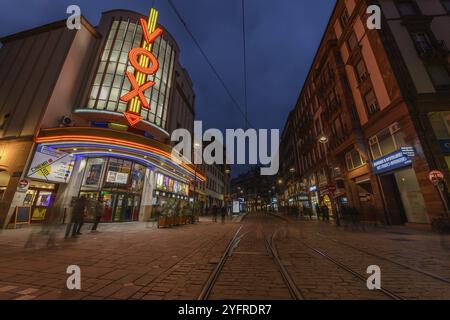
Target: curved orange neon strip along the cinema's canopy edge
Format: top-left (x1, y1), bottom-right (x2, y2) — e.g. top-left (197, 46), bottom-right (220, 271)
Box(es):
top-left (35, 135), bottom-right (206, 181)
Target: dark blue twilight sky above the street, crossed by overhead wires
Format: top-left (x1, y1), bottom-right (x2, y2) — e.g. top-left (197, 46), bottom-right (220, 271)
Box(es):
top-left (0, 0), bottom-right (335, 173)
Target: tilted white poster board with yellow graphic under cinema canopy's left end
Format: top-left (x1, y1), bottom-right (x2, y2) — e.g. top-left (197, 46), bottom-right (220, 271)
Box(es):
top-left (27, 145), bottom-right (75, 183)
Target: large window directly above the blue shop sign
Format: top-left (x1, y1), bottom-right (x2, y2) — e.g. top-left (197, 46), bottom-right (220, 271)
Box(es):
top-left (369, 123), bottom-right (405, 160)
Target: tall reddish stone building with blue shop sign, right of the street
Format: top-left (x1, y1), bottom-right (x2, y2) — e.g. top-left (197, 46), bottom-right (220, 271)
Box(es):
top-left (282, 0), bottom-right (450, 224)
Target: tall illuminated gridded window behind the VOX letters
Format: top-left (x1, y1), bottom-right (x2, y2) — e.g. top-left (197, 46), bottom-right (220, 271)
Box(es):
top-left (87, 20), bottom-right (175, 128)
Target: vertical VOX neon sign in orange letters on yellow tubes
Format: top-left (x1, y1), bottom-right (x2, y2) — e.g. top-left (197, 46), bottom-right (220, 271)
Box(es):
top-left (120, 8), bottom-right (163, 126)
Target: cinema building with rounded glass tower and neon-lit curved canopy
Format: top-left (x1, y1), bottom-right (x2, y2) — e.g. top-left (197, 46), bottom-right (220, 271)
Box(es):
top-left (0, 10), bottom-right (205, 227)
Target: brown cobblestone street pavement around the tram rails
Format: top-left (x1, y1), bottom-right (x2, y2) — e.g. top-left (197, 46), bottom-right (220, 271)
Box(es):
top-left (0, 213), bottom-right (450, 300)
